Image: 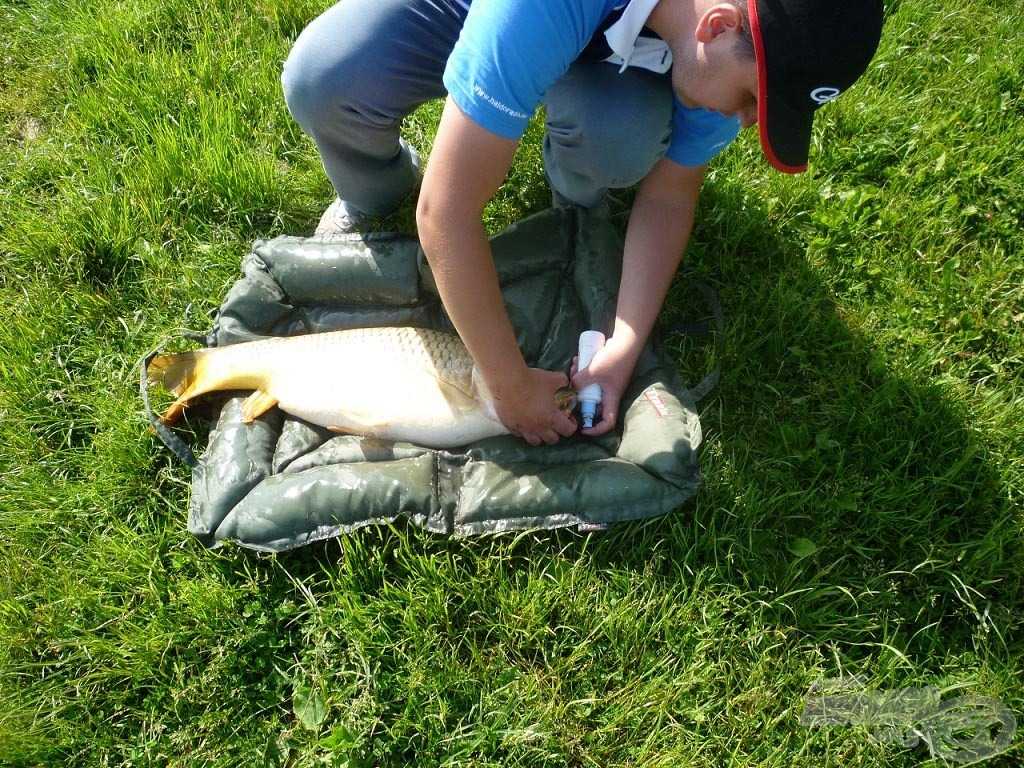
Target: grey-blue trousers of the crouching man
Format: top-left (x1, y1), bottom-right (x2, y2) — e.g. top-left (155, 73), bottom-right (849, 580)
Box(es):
top-left (282, 0), bottom-right (673, 216)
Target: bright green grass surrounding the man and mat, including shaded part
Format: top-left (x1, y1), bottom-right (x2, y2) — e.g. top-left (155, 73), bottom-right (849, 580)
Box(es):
top-left (0, 0), bottom-right (1024, 767)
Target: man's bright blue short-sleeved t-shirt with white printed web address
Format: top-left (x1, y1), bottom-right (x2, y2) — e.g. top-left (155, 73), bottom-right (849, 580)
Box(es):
top-left (444, 0), bottom-right (739, 167)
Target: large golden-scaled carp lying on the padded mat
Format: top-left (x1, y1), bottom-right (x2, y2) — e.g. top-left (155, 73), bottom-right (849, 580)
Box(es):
top-left (146, 327), bottom-right (575, 449)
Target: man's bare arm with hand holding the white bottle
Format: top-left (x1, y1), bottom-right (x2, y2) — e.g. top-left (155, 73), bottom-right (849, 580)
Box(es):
top-left (572, 159), bottom-right (707, 435)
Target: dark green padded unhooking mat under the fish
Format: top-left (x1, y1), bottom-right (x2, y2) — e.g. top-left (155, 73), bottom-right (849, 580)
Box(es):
top-left (143, 209), bottom-right (707, 552)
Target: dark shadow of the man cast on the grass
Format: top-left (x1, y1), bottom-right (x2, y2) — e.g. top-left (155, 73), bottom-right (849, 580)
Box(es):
top-left (266, 177), bottom-right (1024, 658)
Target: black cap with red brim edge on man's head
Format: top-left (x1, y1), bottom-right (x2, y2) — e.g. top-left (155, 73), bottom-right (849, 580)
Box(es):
top-left (748, 0), bottom-right (882, 173)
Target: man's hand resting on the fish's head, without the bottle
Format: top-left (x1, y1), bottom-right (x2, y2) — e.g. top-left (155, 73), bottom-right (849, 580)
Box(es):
top-left (488, 368), bottom-right (577, 445)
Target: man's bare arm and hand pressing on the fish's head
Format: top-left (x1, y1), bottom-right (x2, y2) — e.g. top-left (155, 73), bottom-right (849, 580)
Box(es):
top-left (416, 98), bottom-right (575, 445)
